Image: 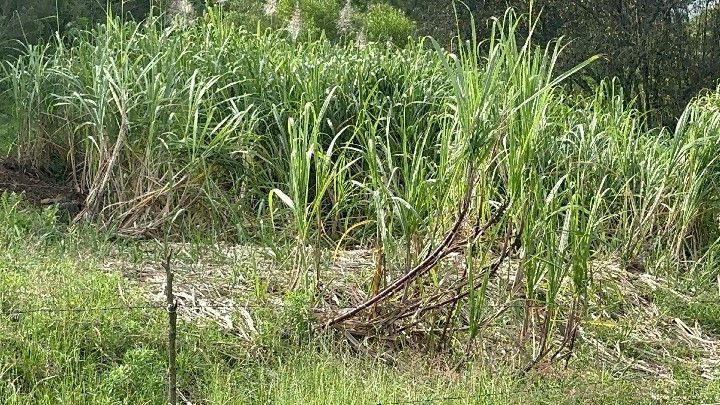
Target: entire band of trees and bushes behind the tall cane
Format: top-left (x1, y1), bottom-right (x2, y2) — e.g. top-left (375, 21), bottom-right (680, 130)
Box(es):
top-left (0, 0), bottom-right (720, 129)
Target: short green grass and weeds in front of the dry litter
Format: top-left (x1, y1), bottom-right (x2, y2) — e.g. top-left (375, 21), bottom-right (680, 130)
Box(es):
top-left (0, 194), bottom-right (720, 404)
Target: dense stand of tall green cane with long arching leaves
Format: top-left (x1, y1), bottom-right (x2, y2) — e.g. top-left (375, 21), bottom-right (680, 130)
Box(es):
top-left (3, 3), bottom-right (720, 354)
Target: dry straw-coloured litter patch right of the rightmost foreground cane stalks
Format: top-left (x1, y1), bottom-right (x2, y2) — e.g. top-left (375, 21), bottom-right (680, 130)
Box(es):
top-left (579, 258), bottom-right (720, 380)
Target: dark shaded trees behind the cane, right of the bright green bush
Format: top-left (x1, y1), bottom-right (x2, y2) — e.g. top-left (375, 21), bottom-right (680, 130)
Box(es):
top-left (390, 0), bottom-right (720, 124)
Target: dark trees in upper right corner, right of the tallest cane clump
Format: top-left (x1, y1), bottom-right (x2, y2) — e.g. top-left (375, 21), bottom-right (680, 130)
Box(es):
top-left (538, 0), bottom-right (720, 124)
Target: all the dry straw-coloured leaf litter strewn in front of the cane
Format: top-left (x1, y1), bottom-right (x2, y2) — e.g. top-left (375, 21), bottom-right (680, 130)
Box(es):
top-left (97, 238), bottom-right (720, 379)
